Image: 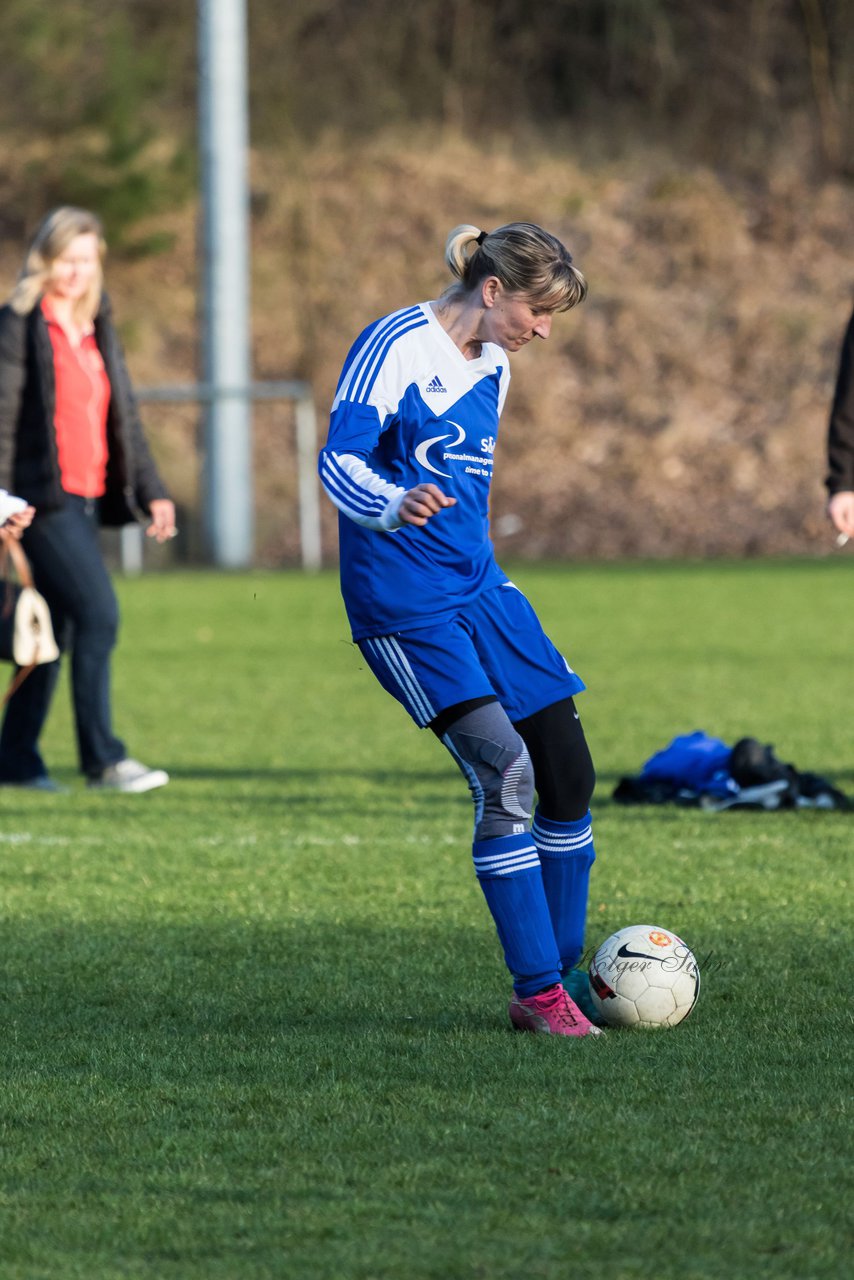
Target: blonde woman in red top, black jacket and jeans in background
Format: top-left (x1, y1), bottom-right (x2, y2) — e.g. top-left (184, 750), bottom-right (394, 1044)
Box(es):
top-left (0, 206), bottom-right (175, 791)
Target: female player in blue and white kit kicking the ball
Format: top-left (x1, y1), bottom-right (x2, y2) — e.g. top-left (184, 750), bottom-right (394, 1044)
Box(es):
top-left (320, 223), bottom-right (599, 1036)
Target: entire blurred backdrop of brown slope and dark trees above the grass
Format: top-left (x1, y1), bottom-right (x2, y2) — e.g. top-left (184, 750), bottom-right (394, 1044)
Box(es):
top-left (0, 0), bottom-right (854, 564)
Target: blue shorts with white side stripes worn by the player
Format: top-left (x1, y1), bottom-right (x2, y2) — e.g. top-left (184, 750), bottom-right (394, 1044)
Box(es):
top-left (359, 582), bottom-right (584, 728)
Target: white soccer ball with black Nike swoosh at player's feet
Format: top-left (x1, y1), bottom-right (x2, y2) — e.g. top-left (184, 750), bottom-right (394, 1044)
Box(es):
top-left (589, 924), bottom-right (700, 1027)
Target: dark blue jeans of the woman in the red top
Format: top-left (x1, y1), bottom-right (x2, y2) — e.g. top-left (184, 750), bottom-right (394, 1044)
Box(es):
top-left (0, 494), bottom-right (127, 782)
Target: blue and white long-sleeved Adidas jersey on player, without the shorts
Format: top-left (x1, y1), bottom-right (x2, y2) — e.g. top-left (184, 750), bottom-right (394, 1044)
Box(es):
top-left (320, 303), bottom-right (510, 640)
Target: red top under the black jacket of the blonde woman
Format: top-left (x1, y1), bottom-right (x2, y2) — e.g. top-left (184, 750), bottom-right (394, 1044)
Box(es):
top-left (41, 298), bottom-right (110, 498)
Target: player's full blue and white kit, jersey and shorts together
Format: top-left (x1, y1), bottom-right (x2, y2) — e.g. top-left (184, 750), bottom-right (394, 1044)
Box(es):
top-left (320, 294), bottom-right (584, 724)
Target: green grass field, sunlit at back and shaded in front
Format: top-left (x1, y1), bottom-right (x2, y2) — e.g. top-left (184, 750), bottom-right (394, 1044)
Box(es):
top-left (0, 557), bottom-right (854, 1280)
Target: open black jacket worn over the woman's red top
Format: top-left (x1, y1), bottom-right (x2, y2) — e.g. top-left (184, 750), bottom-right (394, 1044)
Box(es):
top-left (0, 297), bottom-right (169, 525)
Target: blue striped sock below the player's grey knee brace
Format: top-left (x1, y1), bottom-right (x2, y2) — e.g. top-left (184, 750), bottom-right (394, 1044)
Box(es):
top-left (472, 832), bottom-right (561, 997)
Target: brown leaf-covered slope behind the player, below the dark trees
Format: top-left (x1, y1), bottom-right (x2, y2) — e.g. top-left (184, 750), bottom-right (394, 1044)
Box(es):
top-left (0, 127), bottom-right (854, 564)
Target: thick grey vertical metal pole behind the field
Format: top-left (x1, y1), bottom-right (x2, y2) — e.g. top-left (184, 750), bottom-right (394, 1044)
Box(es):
top-left (198, 0), bottom-right (254, 568)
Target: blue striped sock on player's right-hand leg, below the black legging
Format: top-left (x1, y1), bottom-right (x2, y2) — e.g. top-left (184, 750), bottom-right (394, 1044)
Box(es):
top-left (531, 809), bottom-right (595, 973)
